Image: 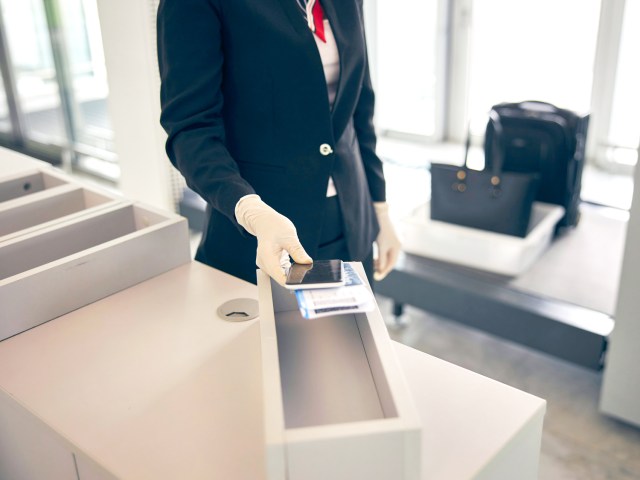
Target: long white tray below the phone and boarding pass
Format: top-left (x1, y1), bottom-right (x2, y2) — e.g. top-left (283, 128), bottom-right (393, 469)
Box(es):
top-left (258, 266), bottom-right (421, 480)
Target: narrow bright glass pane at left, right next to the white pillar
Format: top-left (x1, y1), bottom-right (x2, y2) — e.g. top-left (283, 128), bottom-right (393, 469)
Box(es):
top-left (58, 0), bottom-right (113, 151)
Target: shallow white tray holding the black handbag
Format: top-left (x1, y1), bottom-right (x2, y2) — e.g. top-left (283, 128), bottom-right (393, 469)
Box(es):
top-left (401, 202), bottom-right (564, 276)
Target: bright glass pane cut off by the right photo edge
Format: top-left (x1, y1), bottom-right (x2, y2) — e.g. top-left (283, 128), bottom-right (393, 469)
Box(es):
top-left (609, 0), bottom-right (640, 164)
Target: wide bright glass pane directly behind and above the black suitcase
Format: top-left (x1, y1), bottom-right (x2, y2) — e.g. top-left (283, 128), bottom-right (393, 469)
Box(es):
top-left (469, 0), bottom-right (600, 135)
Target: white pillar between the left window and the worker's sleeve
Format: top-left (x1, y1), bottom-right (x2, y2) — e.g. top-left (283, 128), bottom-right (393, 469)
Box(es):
top-left (98, 0), bottom-right (174, 210)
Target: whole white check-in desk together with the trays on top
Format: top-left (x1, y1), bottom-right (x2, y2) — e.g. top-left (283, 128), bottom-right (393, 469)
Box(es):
top-left (0, 151), bottom-right (545, 480)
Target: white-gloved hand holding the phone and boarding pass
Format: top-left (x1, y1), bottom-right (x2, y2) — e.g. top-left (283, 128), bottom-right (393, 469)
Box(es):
top-left (235, 195), bottom-right (313, 285)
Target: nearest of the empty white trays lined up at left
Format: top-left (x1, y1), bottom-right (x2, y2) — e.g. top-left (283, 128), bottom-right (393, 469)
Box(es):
top-left (0, 203), bottom-right (190, 340)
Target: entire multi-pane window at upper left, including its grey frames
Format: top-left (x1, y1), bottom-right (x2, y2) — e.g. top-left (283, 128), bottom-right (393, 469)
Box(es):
top-left (0, 0), bottom-right (119, 180)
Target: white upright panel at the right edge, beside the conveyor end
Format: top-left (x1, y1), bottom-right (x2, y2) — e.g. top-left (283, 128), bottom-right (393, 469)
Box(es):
top-left (600, 145), bottom-right (640, 425)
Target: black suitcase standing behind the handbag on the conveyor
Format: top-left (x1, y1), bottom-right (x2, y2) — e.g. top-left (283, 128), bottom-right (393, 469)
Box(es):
top-left (484, 101), bottom-right (589, 232)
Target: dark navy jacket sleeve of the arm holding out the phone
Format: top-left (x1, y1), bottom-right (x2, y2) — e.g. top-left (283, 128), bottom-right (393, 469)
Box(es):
top-left (157, 0), bottom-right (255, 231)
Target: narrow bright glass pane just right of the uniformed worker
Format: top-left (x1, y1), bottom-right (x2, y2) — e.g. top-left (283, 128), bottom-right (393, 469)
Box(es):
top-left (375, 0), bottom-right (438, 136)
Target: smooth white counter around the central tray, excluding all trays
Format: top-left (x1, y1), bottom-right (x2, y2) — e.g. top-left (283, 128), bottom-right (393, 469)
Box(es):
top-left (0, 262), bottom-right (545, 480)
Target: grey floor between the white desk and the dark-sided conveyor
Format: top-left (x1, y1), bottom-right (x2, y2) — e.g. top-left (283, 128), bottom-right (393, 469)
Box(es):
top-left (378, 297), bottom-right (640, 480)
